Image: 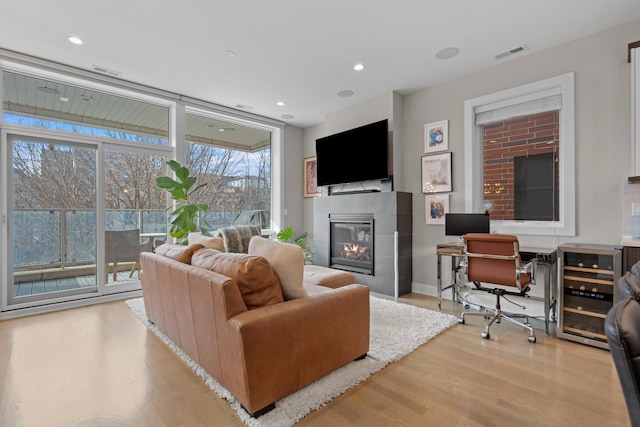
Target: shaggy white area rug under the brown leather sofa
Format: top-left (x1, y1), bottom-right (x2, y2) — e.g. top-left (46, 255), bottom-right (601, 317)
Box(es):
top-left (126, 296), bottom-right (457, 427)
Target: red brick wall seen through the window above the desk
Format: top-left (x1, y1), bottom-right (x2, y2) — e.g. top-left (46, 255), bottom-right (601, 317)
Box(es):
top-left (483, 111), bottom-right (560, 220)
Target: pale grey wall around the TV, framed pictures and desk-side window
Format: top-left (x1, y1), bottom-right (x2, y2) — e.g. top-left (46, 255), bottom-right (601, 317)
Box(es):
top-left (304, 16), bottom-right (640, 293)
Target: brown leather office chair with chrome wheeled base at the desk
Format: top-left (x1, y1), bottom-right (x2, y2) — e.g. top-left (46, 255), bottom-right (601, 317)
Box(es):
top-left (458, 233), bottom-right (536, 343)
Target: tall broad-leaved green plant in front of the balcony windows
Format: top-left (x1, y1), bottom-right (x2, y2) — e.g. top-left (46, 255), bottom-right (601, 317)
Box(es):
top-left (156, 160), bottom-right (211, 245)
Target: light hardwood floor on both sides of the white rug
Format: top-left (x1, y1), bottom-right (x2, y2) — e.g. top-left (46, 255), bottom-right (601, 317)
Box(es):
top-left (0, 294), bottom-right (629, 427)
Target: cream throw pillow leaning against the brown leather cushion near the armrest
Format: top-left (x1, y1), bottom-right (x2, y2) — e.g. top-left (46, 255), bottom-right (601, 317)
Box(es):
top-left (249, 236), bottom-right (307, 301)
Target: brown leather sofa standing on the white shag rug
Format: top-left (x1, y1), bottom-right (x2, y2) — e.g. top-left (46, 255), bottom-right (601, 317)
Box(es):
top-left (141, 245), bottom-right (369, 417)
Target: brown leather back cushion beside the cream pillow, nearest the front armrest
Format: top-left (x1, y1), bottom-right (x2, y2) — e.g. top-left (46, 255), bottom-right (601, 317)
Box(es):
top-left (191, 248), bottom-right (284, 310)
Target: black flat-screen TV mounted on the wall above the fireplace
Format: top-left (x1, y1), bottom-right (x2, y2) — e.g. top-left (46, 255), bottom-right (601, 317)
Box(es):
top-left (316, 119), bottom-right (389, 186)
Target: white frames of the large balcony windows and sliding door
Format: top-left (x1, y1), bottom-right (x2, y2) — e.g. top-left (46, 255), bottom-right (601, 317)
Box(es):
top-left (0, 56), bottom-right (285, 314)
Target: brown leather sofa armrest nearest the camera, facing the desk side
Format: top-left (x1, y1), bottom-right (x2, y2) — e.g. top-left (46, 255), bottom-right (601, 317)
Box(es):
top-left (227, 284), bottom-right (369, 411)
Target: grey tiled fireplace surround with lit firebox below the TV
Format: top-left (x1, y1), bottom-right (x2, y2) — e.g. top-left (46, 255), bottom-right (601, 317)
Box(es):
top-left (313, 191), bottom-right (413, 296)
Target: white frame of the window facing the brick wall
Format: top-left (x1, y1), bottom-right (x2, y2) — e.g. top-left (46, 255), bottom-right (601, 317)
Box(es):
top-left (464, 72), bottom-right (576, 236)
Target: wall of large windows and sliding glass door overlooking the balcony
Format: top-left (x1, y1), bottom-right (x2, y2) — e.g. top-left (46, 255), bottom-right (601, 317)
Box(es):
top-left (0, 56), bottom-right (282, 318)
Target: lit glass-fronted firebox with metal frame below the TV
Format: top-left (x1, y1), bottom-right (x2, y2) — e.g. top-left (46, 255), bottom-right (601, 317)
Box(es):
top-left (329, 214), bottom-right (374, 275)
